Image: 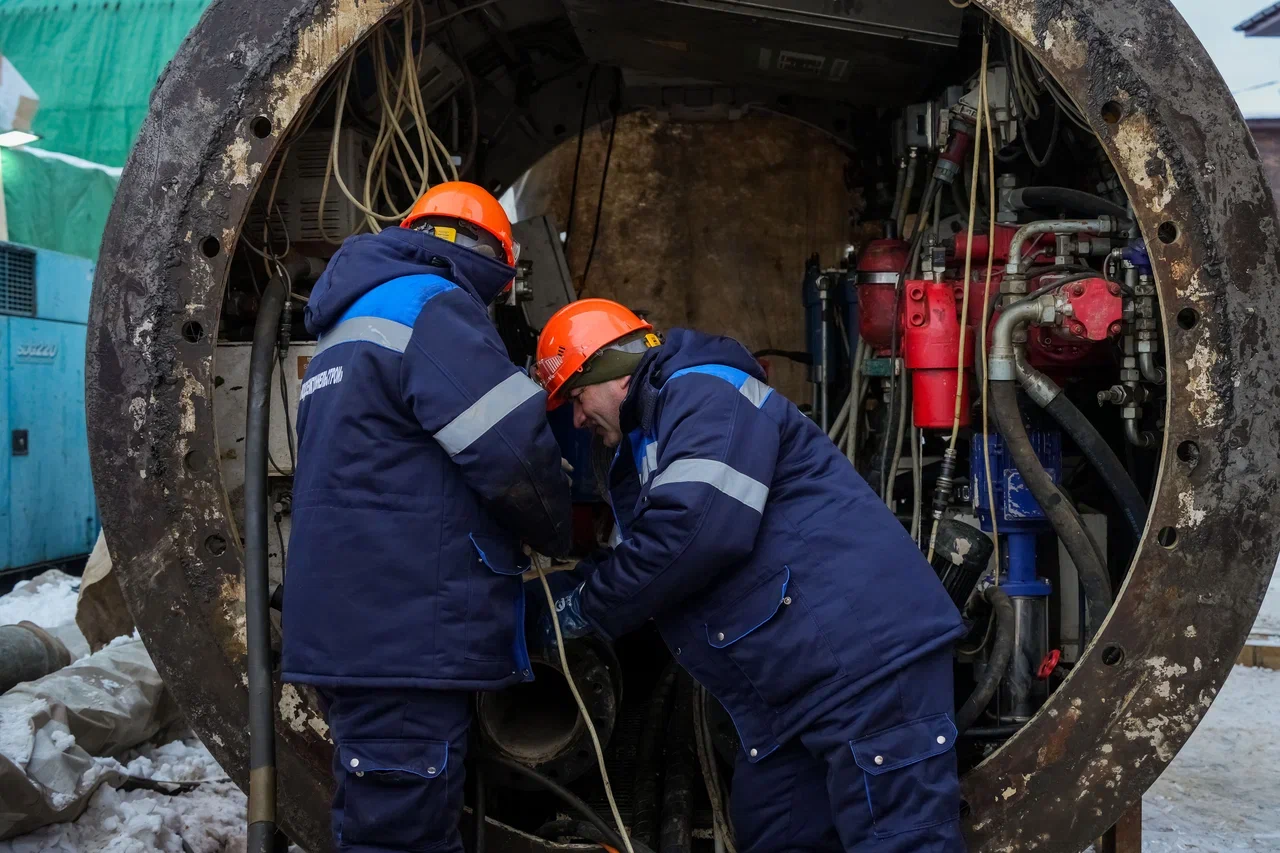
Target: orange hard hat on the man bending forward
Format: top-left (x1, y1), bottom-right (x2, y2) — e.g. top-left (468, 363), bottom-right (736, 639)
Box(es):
top-left (534, 298), bottom-right (658, 410)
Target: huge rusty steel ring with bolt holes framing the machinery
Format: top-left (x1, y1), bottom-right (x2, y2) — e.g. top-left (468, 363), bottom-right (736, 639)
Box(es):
top-left (87, 0), bottom-right (1280, 850)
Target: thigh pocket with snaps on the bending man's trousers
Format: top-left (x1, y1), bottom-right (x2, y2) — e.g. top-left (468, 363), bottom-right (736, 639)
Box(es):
top-left (849, 713), bottom-right (960, 838)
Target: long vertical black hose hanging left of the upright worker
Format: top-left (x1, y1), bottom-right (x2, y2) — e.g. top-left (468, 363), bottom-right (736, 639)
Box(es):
top-left (244, 274), bottom-right (288, 853)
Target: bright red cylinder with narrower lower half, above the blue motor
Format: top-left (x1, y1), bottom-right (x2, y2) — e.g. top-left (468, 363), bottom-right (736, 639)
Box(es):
top-left (902, 282), bottom-right (974, 429)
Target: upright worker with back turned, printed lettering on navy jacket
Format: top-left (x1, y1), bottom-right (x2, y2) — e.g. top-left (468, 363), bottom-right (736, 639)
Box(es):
top-left (282, 183), bottom-right (570, 853)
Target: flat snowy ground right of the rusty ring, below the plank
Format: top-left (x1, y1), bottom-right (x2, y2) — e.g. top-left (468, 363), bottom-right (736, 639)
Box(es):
top-left (1142, 666), bottom-right (1280, 853)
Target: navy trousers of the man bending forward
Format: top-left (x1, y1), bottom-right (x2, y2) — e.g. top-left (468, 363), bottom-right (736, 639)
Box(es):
top-left (730, 651), bottom-right (965, 853)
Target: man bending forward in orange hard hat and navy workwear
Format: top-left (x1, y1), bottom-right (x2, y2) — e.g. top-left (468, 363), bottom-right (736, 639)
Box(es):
top-left (536, 300), bottom-right (964, 853)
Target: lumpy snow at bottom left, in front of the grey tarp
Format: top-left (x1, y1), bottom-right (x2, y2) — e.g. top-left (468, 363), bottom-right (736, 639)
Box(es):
top-left (0, 738), bottom-right (246, 853)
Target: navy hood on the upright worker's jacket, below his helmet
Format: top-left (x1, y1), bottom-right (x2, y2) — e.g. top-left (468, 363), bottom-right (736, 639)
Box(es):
top-left (306, 228), bottom-right (516, 336)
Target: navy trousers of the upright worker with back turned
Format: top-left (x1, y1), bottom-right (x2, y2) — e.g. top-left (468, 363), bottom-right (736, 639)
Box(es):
top-left (320, 688), bottom-right (472, 853)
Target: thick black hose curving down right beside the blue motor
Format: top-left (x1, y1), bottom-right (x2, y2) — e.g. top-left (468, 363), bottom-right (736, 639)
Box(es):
top-left (991, 379), bottom-right (1111, 631)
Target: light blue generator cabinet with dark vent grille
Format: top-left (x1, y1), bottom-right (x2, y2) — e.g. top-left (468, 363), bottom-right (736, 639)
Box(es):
top-left (0, 242), bottom-right (99, 581)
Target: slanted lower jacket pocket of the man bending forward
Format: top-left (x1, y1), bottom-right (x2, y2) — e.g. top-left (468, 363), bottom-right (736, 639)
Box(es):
top-left (704, 566), bottom-right (844, 708)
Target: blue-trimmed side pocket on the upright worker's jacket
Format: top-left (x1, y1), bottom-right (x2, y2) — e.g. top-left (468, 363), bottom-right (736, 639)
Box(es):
top-left (465, 534), bottom-right (529, 669)
